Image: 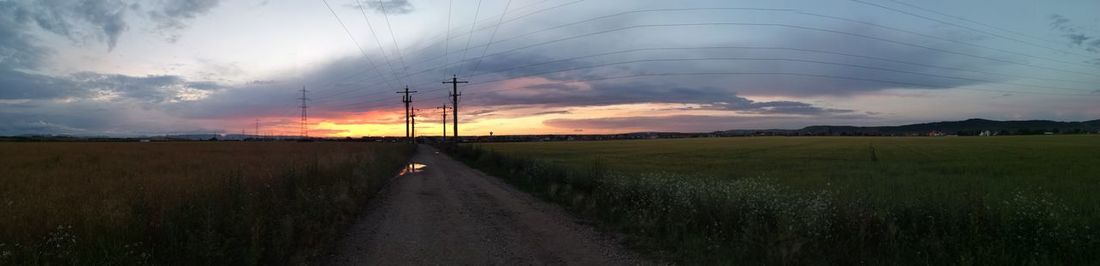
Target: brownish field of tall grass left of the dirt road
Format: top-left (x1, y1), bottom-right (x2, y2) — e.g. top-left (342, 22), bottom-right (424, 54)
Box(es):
top-left (0, 142), bottom-right (414, 265)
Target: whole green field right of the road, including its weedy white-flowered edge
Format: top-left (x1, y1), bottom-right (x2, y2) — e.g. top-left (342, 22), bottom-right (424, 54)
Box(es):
top-left (452, 135), bottom-right (1100, 264)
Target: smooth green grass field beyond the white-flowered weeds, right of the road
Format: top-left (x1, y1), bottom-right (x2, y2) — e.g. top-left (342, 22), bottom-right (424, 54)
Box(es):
top-left (481, 135), bottom-right (1100, 208)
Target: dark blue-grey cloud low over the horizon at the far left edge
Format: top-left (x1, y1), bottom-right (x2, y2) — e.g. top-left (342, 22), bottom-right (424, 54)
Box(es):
top-left (0, 69), bottom-right (238, 135)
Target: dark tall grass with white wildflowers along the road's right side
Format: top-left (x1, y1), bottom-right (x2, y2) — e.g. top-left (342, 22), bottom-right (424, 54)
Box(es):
top-left (448, 142), bottom-right (1100, 265)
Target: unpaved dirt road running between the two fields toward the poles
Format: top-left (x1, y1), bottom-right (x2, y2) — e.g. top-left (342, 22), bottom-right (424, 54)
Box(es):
top-left (330, 145), bottom-right (642, 265)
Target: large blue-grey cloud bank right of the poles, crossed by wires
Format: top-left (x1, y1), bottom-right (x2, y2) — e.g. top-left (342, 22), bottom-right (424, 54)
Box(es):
top-left (446, 20), bottom-right (1008, 100)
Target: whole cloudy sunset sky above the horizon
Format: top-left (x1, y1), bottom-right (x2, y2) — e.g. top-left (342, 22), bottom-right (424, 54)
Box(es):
top-left (0, 0), bottom-right (1100, 136)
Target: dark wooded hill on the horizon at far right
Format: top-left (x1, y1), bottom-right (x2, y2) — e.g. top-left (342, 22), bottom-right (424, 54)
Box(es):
top-left (719, 119), bottom-right (1100, 135)
